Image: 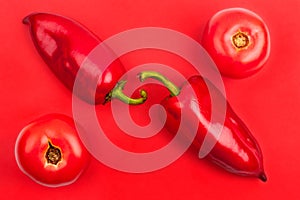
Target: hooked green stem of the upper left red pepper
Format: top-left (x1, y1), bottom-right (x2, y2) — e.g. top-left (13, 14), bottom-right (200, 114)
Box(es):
top-left (105, 80), bottom-right (147, 105)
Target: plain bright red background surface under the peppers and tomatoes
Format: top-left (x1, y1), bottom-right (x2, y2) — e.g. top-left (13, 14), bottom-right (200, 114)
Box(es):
top-left (0, 0), bottom-right (300, 200)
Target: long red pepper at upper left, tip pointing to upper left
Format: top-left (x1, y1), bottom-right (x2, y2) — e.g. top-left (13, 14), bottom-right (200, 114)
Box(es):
top-left (23, 13), bottom-right (147, 104)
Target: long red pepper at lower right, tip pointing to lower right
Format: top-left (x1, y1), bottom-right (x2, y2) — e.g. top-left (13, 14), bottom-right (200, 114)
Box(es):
top-left (139, 71), bottom-right (267, 181)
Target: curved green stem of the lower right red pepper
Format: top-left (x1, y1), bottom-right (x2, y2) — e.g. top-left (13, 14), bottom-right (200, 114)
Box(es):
top-left (138, 71), bottom-right (180, 96)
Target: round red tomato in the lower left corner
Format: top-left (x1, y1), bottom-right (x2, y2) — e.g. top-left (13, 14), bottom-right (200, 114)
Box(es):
top-left (15, 114), bottom-right (90, 187)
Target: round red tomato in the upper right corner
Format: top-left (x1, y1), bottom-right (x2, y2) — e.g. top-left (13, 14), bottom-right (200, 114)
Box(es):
top-left (202, 8), bottom-right (270, 78)
